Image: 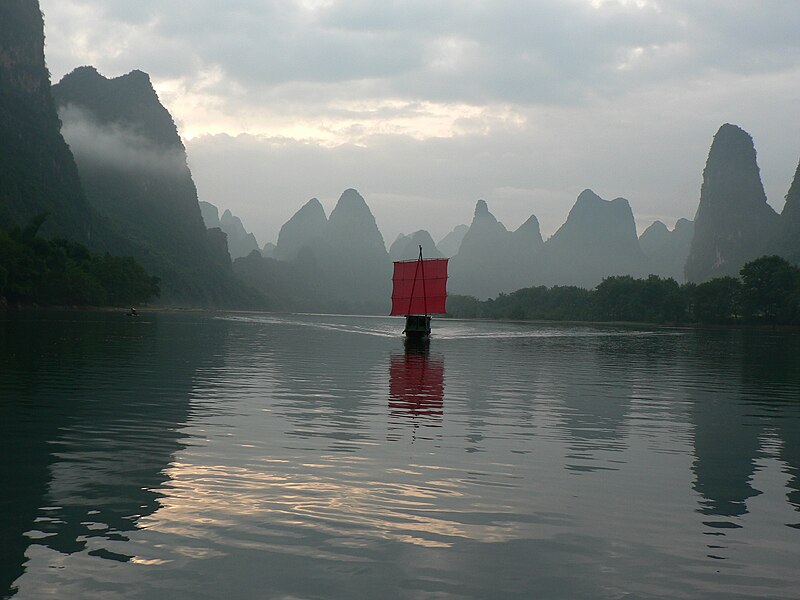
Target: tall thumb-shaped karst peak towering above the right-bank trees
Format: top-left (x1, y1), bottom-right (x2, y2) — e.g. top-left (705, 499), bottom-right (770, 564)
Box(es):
top-left (686, 123), bottom-right (779, 282)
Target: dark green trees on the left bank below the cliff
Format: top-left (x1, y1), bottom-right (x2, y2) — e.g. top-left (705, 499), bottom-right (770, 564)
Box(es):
top-left (0, 215), bottom-right (159, 306)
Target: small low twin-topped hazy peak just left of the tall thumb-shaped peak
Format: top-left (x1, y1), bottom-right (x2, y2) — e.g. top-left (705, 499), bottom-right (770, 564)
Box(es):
top-left (639, 219), bottom-right (694, 283)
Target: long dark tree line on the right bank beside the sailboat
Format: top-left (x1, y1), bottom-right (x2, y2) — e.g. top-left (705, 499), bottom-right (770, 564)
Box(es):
top-left (448, 256), bottom-right (800, 325)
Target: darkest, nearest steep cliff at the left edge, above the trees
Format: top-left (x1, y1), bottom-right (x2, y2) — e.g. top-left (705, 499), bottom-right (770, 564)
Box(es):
top-left (0, 0), bottom-right (94, 244)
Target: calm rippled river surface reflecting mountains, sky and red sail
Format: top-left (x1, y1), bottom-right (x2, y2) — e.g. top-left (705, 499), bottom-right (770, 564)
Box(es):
top-left (0, 312), bottom-right (800, 599)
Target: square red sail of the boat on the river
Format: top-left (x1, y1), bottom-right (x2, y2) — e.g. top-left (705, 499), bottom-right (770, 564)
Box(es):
top-left (392, 258), bottom-right (448, 315)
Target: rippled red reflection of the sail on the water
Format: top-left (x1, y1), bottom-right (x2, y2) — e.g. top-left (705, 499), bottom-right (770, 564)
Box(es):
top-left (389, 345), bottom-right (444, 420)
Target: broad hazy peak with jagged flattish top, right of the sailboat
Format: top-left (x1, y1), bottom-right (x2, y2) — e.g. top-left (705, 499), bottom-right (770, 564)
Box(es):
top-left (537, 189), bottom-right (647, 288)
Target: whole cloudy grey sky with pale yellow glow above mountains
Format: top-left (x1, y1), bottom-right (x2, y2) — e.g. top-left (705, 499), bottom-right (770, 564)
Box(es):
top-left (41, 0), bottom-right (800, 245)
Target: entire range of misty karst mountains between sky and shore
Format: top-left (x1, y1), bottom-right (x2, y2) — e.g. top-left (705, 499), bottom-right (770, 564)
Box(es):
top-left (0, 0), bottom-right (800, 313)
